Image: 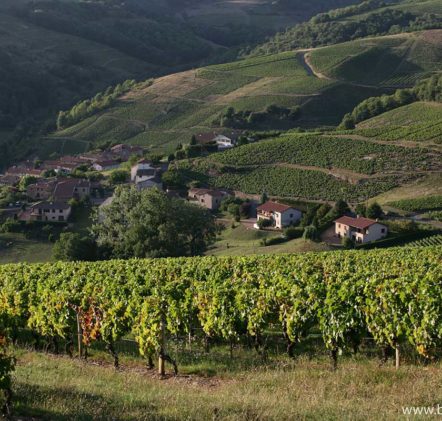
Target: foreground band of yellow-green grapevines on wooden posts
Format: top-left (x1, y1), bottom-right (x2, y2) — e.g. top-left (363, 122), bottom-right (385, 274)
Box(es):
top-left (0, 247), bottom-right (442, 378)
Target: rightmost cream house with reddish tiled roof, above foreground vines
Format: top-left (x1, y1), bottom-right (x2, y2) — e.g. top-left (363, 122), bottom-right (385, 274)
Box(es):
top-left (335, 216), bottom-right (388, 244)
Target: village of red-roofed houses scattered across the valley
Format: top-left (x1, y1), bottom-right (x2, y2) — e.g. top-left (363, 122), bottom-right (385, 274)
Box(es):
top-left (0, 131), bottom-right (388, 258)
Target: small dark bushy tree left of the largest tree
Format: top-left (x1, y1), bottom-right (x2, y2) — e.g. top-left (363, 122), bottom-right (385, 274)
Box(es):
top-left (53, 232), bottom-right (97, 262)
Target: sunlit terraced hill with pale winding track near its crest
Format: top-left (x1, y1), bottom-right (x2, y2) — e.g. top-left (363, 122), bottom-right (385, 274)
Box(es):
top-left (48, 31), bottom-right (442, 156)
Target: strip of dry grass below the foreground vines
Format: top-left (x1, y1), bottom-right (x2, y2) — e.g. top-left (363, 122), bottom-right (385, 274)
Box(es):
top-left (9, 351), bottom-right (442, 420)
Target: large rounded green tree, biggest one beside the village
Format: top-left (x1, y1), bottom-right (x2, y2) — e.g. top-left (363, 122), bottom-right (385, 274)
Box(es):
top-left (92, 186), bottom-right (218, 258)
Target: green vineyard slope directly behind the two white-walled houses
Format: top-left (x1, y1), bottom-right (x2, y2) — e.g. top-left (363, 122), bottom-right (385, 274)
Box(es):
top-left (176, 134), bottom-right (442, 202)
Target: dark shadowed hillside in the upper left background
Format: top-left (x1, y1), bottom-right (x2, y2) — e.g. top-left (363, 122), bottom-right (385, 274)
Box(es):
top-left (0, 0), bottom-right (360, 166)
